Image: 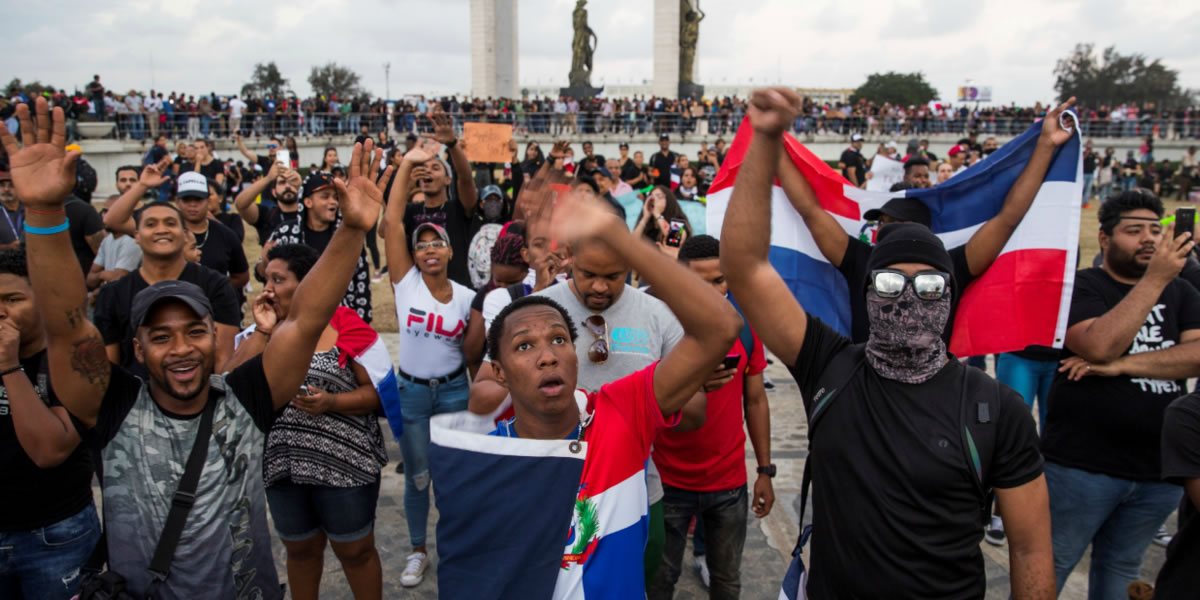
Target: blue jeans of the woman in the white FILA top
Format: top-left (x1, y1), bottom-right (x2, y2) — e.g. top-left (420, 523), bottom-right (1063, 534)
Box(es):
top-left (400, 373), bottom-right (470, 547)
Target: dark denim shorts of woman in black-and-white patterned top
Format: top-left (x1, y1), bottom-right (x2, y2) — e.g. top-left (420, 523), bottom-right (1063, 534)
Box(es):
top-left (266, 479), bottom-right (379, 544)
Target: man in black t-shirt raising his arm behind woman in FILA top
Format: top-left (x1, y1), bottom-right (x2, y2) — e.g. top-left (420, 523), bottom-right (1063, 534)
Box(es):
top-left (404, 113), bottom-right (479, 287)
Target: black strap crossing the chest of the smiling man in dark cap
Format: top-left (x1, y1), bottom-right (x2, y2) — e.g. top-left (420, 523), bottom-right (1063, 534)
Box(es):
top-left (146, 389), bottom-right (220, 599)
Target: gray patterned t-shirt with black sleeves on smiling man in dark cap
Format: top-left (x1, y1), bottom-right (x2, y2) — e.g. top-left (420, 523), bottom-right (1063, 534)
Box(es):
top-left (80, 356), bottom-right (283, 600)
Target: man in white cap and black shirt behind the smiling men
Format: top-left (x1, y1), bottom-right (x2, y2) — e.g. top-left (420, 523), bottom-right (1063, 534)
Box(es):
top-left (104, 172), bottom-right (250, 294)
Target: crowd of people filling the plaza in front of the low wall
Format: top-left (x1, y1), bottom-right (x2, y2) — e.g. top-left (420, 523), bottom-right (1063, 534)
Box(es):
top-left (0, 85), bottom-right (1200, 600)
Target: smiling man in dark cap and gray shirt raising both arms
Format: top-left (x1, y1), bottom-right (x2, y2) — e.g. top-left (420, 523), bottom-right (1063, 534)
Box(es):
top-left (0, 98), bottom-right (379, 599)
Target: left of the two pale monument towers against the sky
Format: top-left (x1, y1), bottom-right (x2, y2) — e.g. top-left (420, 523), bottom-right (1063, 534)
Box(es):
top-left (470, 0), bottom-right (518, 98)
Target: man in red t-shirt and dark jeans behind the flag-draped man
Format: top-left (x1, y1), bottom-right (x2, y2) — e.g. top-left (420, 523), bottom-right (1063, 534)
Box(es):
top-left (648, 235), bottom-right (775, 600)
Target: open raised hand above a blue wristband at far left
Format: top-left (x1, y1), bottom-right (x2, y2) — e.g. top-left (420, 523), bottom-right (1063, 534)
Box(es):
top-left (0, 97), bottom-right (79, 210)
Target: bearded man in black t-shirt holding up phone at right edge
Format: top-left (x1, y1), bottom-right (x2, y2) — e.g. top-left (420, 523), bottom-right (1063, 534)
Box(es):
top-left (1041, 190), bottom-right (1200, 598)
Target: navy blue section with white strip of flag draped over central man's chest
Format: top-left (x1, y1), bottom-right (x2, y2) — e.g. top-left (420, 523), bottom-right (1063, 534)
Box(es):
top-left (430, 413), bottom-right (587, 600)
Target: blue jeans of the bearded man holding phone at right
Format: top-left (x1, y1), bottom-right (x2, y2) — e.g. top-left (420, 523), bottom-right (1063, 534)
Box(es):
top-left (1045, 461), bottom-right (1183, 600)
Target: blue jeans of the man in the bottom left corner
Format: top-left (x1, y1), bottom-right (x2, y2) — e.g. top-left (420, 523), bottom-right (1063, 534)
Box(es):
top-left (0, 504), bottom-right (100, 600)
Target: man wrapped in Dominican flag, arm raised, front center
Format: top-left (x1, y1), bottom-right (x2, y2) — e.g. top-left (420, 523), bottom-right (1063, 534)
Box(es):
top-left (430, 186), bottom-right (742, 599)
